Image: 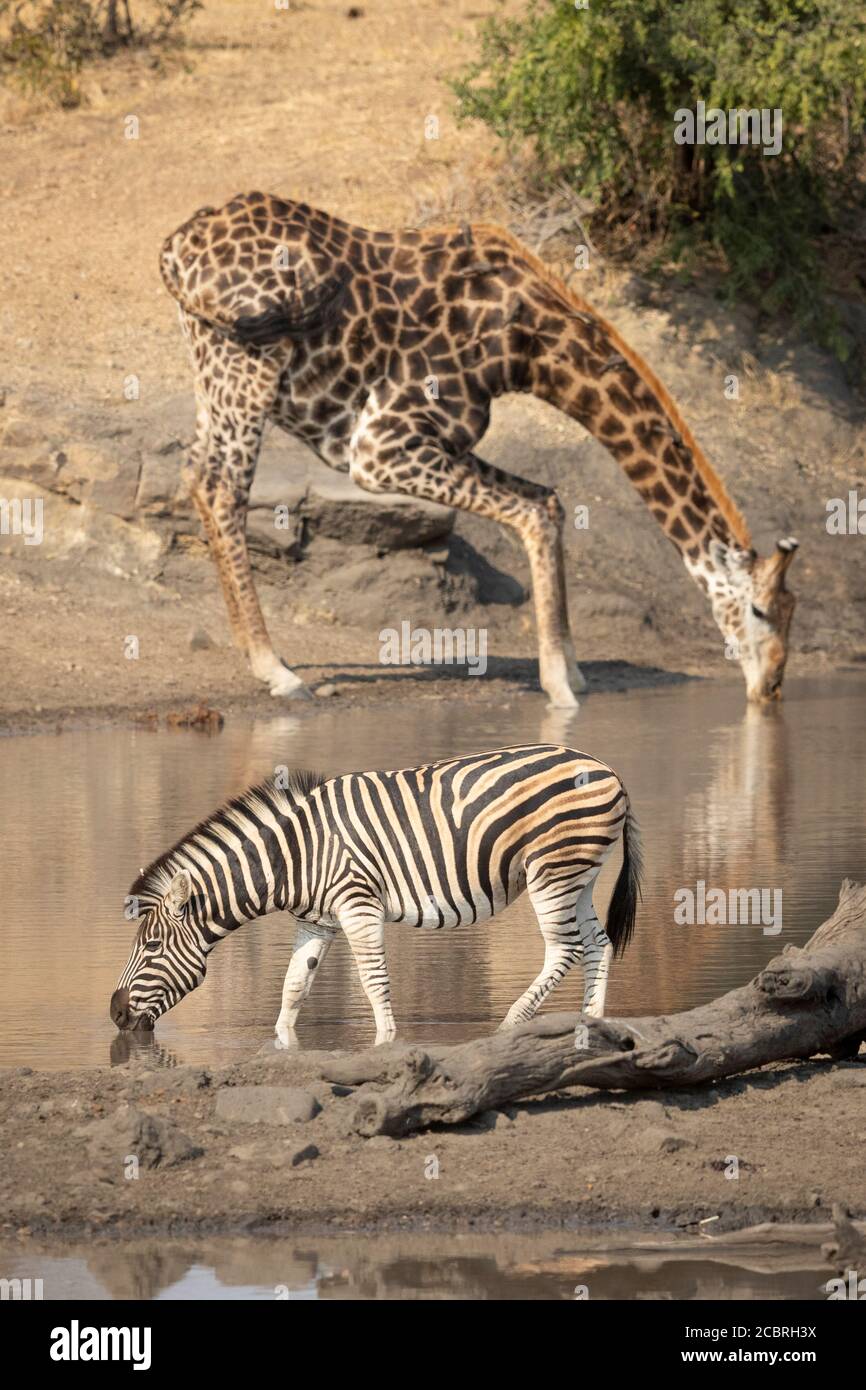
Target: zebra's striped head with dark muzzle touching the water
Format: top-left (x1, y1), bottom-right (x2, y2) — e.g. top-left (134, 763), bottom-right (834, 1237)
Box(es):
top-left (110, 869), bottom-right (209, 1031)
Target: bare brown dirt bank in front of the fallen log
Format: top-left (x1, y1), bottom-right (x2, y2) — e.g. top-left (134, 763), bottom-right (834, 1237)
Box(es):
top-left (0, 1040), bottom-right (866, 1240)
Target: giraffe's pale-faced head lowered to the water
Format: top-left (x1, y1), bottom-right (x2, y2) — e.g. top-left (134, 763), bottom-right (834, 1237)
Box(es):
top-left (709, 537), bottom-right (798, 703)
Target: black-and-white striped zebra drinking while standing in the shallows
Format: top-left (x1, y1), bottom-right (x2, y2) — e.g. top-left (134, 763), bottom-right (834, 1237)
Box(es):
top-left (110, 744), bottom-right (641, 1047)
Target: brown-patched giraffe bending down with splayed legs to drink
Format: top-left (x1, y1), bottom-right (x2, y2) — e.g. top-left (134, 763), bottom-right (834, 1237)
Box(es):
top-left (160, 193), bottom-right (796, 709)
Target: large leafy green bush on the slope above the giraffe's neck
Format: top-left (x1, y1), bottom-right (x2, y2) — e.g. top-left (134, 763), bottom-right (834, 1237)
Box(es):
top-left (452, 0), bottom-right (866, 356)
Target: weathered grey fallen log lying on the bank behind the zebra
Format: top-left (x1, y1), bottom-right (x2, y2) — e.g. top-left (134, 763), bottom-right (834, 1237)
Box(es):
top-left (322, 880), bottom-right (866, 1136)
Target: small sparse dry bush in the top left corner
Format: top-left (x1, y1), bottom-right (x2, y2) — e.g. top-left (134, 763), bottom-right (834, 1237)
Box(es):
top-left (0, 0), bottom-right (202, 107)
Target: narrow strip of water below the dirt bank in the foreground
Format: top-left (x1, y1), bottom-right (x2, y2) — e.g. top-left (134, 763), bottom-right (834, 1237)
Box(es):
top-left (0, 1232), bottom-right (828, 1301)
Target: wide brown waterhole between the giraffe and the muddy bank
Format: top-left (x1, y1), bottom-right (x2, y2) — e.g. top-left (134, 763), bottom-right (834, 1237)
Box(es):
top-left (0, 674), bottom-right (866, 1069)
